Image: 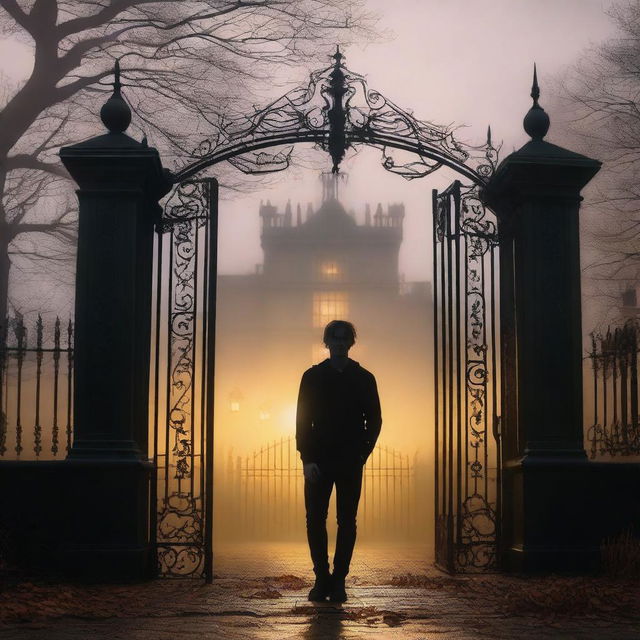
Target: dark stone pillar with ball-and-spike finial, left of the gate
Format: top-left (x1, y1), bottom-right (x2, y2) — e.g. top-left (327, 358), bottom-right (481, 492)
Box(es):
top-left (60, 64), bottom-right (170, 579)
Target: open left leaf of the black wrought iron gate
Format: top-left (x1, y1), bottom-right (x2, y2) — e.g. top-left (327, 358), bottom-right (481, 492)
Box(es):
top-left (150, 179), bottom-right (218, 581)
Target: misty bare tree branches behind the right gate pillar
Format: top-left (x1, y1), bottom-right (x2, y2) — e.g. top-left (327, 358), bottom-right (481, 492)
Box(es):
top-left (558, 0), bottom-right (640, 322)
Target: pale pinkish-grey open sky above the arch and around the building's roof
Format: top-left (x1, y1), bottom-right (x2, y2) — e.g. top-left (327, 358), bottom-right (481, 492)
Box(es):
top-left (0, 0), bottom-right (614, 280)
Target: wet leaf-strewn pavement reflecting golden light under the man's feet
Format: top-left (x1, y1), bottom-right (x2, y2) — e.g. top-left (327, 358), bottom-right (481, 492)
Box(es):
top-left (0, 543), bottom-right (640, 640)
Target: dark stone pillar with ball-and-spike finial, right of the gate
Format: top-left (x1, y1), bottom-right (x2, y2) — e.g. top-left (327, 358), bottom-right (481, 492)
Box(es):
top-left (484, 70), bottom-right (600, 571)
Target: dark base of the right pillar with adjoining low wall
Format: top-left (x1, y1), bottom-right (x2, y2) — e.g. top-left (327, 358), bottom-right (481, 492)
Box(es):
top-left (501, 456), bottom-right (640, 574)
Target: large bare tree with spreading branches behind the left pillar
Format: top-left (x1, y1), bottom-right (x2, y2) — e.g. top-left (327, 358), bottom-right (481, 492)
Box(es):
top-left (0, 0), bottom-right (374, 319)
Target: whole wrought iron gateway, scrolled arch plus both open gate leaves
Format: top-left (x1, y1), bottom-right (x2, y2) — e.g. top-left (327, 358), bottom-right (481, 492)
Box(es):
top-left (151, 50), bottom-right (500, 581)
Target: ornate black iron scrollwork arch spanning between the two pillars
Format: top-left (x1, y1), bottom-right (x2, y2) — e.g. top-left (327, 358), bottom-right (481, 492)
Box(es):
top-left (176, 48), bottom-right (498, 184)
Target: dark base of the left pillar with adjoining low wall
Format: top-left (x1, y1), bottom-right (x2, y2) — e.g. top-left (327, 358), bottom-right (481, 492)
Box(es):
top-left (0, 459), bottom-right (156, 582)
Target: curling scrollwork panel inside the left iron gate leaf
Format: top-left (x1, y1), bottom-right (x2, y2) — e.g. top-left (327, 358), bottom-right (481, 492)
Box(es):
top-left (156, 181), bottom-right (209, 576)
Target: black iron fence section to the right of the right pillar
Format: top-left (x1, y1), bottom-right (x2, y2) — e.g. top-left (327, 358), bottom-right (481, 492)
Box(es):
top-left (587, 321), bottom-right (640, 458)
